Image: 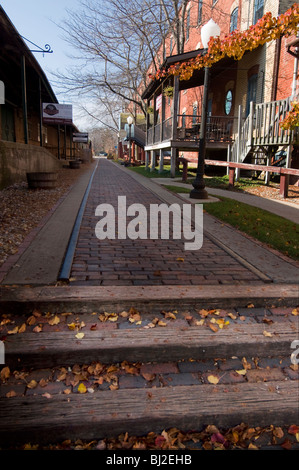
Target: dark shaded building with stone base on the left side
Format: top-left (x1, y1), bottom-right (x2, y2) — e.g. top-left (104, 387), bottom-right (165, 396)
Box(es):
top-left (0, 6), bottom-right (88, 188)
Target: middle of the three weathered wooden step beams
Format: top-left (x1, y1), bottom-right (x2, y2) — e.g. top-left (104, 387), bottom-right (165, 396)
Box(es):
top-left (5, 321), bottom-right (298, 368)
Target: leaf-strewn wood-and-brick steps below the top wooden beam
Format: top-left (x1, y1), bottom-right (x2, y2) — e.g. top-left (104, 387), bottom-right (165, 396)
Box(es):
top-left (0, 296), bottom-right (299, 447)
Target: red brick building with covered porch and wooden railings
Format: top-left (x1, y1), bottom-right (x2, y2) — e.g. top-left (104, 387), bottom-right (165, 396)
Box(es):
top-left (132, 0), bottom-right (298, 181)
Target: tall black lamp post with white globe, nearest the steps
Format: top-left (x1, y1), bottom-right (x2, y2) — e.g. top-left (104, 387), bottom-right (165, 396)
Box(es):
top-left (190, 19), bottom-right (220, 199)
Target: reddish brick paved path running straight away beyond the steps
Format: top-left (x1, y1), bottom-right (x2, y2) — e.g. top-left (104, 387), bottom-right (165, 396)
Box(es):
top-left (70, 159), bottom-right (261, 286)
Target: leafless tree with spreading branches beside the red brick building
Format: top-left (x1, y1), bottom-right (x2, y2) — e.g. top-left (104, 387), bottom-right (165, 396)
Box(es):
top-left (54, 0), bottom-right (195, 130)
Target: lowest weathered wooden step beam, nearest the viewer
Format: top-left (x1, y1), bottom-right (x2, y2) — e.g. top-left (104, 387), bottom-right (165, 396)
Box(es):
top-left (0, 381), bottom-right (298, 446)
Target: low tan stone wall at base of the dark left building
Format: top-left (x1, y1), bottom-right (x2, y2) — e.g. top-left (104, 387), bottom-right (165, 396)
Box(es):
top-left (0, 141), bottom-right (61, 189)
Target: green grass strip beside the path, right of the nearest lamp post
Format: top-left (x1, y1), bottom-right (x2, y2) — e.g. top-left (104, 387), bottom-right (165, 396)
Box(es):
top-left (165, 185), bottom-right (299, 260)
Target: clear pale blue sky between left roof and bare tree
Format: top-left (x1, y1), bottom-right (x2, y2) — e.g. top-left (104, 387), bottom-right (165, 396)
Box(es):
top-left (0, 0), bottom-right (90, 131)
